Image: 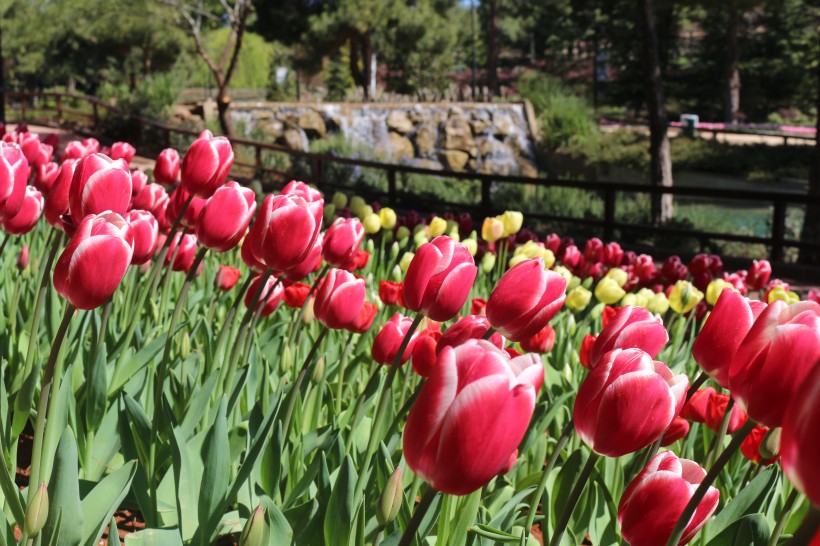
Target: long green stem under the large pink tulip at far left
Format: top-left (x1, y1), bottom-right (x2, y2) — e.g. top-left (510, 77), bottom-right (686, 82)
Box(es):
top-left (28, 303), bottom-right (77, 503)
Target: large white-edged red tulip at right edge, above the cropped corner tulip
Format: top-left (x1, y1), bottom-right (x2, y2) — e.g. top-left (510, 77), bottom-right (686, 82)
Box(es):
top-left (729, 300), bottom-right (820, 428)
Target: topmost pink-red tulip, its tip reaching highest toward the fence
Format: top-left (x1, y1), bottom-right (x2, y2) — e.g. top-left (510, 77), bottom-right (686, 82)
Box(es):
top-left (179, 130), bottom-right (233, 199)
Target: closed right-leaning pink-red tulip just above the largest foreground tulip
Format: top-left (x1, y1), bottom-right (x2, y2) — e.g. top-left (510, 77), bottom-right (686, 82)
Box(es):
top-left (486, 258), bottom-right (567, 341)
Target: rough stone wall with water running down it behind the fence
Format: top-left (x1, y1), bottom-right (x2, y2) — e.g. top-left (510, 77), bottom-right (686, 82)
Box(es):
top-left (230, 102), bottom-right (537, 176)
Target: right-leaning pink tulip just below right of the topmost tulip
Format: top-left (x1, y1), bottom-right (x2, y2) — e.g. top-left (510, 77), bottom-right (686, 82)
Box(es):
top-left (196, 182), bottom-right (256, 252)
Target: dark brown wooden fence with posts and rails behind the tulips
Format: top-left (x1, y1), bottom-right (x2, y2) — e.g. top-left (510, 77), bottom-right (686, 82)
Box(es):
top-left (8, 88), bottom-right (820, 268)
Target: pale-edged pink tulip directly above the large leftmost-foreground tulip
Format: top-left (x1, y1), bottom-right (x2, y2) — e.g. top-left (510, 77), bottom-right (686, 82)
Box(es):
top-left (68, 154), bottom-right (131, 218)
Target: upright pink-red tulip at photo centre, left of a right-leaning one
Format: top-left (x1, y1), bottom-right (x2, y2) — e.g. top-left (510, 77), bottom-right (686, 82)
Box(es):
top-left (404, 236), bottom-right (478, 321)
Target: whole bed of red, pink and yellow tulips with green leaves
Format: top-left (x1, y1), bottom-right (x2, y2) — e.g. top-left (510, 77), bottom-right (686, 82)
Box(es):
top-left (0, 123), bottom-right (820, 546)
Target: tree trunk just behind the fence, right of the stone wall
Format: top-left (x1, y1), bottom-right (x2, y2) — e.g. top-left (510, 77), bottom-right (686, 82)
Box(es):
top-left (638, 0), bottom-right (672, 225)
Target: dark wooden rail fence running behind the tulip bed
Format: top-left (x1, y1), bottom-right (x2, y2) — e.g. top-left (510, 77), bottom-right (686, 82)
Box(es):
top-left (8, 93), bottom-right (820, 274)
